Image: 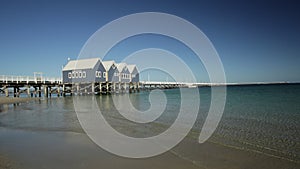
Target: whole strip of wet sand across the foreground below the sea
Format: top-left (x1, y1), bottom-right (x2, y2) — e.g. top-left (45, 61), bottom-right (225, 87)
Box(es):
top-left (0, 128), bottom-right (300, 169)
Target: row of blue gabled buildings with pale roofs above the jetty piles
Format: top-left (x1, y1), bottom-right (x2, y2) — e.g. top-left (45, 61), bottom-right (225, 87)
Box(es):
top-left (62, 58), bottom-right (139, 94)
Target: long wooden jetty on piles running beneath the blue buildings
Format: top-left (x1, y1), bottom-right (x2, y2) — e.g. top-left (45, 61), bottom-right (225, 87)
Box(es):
top-left (0, 75), bottom-right (195, 97)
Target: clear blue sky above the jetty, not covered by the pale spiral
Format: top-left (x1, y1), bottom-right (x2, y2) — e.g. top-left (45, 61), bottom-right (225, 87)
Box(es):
top-left (0, 0), bottom-right (300, 82)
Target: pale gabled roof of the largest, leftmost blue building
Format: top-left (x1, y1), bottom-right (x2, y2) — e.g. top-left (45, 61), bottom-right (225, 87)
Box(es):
top-left (63, 58), bottom-right (100, 71)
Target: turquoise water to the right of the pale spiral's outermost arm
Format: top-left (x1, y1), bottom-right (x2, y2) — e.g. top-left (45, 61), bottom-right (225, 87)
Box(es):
top-left (212, 85), bottom-right (300, 161)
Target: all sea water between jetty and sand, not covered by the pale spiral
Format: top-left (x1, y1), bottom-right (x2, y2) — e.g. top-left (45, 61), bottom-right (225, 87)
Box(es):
top-left (0, 84), bottom-right (300, 163)
